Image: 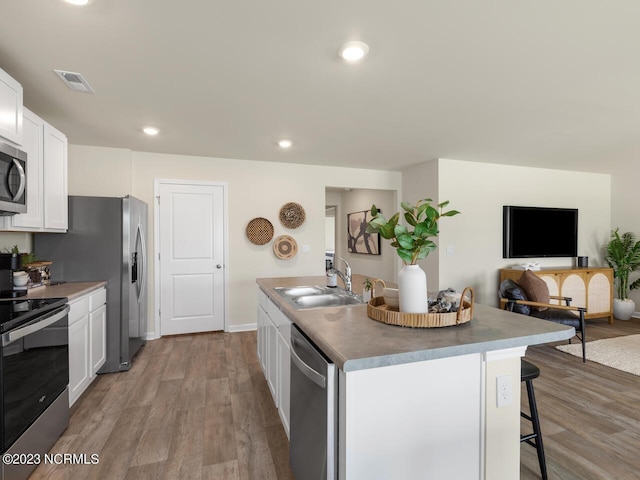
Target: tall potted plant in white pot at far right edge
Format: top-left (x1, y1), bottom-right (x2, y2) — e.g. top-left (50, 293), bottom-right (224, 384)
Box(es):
top-left (605, 228), bottom-right (640, 320)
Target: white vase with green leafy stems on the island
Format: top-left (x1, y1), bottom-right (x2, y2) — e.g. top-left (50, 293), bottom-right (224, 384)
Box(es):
top-left (367, 198), bottom-right (460, 313)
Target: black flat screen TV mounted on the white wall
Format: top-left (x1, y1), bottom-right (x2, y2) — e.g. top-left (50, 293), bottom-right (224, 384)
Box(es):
top-left (502, 205), bottom-right (578, 258)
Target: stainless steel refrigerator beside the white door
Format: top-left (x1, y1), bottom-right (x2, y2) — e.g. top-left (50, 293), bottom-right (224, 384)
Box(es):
top-left (34, 195), bottom-right (148, 373)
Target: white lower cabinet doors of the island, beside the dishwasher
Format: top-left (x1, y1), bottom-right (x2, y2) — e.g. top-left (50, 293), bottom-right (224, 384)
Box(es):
top-left (257, 290), bottom-right (291, 437)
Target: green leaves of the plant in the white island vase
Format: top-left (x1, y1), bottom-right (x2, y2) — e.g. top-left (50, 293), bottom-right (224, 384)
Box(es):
top-left (367, 198), bottom-right (460, 265)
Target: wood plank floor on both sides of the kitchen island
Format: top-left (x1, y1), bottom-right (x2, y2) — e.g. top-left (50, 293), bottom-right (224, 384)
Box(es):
top-left (31, 320), bottom-right (640, 480)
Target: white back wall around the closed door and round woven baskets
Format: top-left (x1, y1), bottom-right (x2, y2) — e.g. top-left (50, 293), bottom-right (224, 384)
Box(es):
top-left (69, 146), bottom-right (401, 332)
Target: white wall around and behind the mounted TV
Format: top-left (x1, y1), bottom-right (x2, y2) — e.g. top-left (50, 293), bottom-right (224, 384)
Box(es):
top-left (438, 159), bottom-right (611, 305)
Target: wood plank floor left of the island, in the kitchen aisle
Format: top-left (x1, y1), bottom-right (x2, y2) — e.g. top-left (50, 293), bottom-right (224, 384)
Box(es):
top-left (31, 332), bottom-right (293, 480)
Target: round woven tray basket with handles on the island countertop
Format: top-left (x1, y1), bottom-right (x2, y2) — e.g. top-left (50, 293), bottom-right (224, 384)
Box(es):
top-left (367, 287), bottom-right (473, 328)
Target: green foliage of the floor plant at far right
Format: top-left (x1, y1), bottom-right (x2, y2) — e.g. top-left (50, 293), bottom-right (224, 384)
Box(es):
top-left (605, 228), bottom-right (640, 300)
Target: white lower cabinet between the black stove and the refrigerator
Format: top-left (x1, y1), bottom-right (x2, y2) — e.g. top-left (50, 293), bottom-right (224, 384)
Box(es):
top-left (69, 288), bottom-right (107, 406)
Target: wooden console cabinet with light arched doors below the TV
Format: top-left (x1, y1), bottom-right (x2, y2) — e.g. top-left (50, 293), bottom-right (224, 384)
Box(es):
top-left (500, 267), bottom-right (613, 323)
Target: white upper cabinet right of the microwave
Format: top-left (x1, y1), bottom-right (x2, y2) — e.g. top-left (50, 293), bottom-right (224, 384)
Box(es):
top-left (2, 108), bottom-right (68, 232)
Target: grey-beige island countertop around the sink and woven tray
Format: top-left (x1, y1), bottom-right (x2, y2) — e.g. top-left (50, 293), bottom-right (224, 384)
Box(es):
top-left (256, 275), bottom-right (575, 372)
